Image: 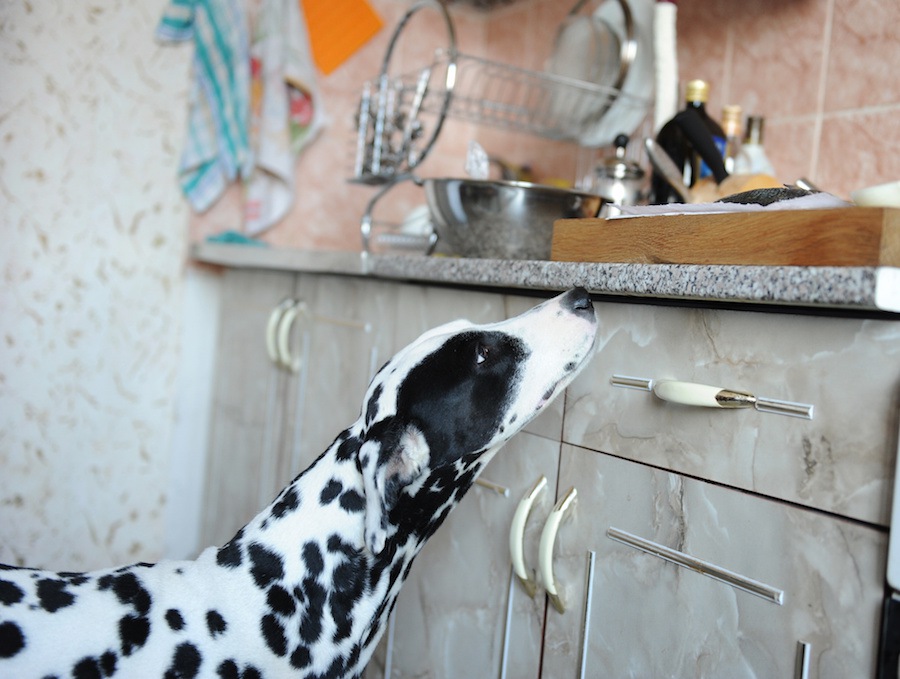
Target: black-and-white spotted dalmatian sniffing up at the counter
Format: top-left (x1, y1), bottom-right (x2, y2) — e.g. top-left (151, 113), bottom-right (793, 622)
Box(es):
top-left (0, 288), bottom-right (597, 679)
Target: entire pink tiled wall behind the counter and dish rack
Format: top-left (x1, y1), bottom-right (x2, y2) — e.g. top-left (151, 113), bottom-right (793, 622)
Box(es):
top-left (193, 0), bottom-right (900, 250)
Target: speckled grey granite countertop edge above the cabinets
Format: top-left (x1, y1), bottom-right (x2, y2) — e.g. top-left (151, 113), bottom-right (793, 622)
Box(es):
top-left (192, 243), bottom-right (900, 313)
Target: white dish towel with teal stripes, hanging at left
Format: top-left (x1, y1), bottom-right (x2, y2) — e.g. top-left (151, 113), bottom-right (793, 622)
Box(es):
top-left (156, 0), bottom-right (253, 212)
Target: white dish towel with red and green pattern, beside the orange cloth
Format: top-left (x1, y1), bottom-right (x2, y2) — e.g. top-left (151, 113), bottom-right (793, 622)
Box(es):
top-left (244, 0), bottom-right (325, 235)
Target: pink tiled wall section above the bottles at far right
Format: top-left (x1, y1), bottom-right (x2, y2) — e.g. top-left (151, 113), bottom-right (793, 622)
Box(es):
top-left (678, 0), bottom-right (900, 202)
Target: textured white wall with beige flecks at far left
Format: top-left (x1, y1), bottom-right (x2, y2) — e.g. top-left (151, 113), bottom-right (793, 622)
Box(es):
top-left (0, 0), bottom-right (190, 570)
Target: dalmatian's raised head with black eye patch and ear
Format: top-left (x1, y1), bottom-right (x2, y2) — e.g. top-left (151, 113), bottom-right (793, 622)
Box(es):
top-left (358, 288), bottom-right (597, 554)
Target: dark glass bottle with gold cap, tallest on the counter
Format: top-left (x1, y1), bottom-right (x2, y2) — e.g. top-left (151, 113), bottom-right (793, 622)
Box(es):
top-left (650, 80), bottom-right (725, 204)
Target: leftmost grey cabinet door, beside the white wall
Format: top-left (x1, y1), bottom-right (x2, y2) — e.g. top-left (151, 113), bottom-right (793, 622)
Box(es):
top-left (200, 269), bottom-right (295, 546)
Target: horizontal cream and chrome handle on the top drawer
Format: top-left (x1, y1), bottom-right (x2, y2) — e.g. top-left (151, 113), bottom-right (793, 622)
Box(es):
top-left (610, 375), bottom-right (814, 420)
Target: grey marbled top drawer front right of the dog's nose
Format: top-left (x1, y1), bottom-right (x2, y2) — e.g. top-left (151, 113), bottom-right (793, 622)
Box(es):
top-left (563, 303), bottom-right (900, 525)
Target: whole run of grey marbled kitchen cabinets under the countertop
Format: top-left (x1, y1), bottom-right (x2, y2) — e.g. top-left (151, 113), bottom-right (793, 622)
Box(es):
top-left (205, 269), bottom-right (900, 679)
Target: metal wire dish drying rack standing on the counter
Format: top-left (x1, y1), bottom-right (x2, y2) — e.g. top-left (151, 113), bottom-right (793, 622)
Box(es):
top-left (351, 0), bottom-right (649, 252)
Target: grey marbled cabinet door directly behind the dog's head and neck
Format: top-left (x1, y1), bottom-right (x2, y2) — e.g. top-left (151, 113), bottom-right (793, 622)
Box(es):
top-left (366, 286), bottom-right (562, 679)
